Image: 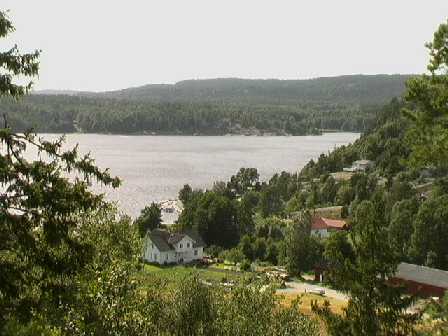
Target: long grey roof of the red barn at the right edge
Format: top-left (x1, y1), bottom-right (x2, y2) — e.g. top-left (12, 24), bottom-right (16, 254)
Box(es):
top-left (394, 263), bottom-right (448, 289)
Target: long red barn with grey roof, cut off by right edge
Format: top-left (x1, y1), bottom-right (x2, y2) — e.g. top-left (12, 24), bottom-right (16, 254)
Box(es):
top-left (389, 263), bottom-right (448, 297)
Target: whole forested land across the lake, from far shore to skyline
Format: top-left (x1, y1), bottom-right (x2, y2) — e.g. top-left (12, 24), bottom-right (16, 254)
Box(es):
top-left (4, 75), bottom-right (410, 135)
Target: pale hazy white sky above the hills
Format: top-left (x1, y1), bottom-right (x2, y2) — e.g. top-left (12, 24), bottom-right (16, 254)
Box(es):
top-left (0, 0), bottom-right (448, 91)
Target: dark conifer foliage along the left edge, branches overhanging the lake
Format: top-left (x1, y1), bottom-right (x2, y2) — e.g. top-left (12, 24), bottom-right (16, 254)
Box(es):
top-left (0, 7), bottom-right (120, 330)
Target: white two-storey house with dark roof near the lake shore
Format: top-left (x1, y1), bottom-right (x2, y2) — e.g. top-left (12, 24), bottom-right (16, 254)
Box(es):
top-left (143, 229), bottom-right (205, 265)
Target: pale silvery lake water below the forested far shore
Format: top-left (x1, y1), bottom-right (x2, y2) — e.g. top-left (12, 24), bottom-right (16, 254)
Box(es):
top-left (38, 133), bottom-right (359, 217)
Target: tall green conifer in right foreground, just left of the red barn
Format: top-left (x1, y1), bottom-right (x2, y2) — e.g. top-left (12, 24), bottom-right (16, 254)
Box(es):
top-left (313, 201), bottom-right (416, 336)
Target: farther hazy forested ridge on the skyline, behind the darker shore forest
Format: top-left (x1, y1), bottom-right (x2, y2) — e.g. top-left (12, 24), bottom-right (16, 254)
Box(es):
top-left (92, 75), bottom-right (410, 105)
